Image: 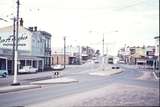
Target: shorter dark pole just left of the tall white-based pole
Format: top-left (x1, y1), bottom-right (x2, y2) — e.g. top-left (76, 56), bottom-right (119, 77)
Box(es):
top-left (12, 17), bottom-right (16, 73)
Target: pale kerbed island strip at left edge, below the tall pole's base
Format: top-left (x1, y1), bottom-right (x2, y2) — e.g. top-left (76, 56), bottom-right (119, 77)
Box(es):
top-left (0, 85), bottom-right (41, 93)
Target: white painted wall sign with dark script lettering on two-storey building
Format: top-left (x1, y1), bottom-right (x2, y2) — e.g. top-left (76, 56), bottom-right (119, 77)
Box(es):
top-left (0, 32), bottom-right (30, 50)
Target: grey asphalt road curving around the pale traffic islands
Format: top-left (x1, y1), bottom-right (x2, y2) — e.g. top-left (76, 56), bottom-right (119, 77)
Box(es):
top-left (0, 64), bottom-right (159, 107)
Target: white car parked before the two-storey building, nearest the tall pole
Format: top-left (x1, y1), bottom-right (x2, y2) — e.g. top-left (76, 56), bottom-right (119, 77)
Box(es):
top-left (18, 66), bottom-right (38, 73)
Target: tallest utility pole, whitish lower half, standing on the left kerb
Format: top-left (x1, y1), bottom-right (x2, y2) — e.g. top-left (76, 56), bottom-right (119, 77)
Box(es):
top-left (12, 0), bottom-right (20, 85)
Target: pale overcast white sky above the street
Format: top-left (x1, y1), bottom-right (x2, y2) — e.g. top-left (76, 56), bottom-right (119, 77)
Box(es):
top-left (0, 0), bottom-right (159, 55)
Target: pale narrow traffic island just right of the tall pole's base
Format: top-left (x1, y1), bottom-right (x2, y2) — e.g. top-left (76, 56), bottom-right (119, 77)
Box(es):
top-left (31, 77), bottom-right (78, 85)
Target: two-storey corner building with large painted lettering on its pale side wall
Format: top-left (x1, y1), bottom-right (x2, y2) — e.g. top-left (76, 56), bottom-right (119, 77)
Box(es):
top-left (0, 24), bottom-right (51, 74)
